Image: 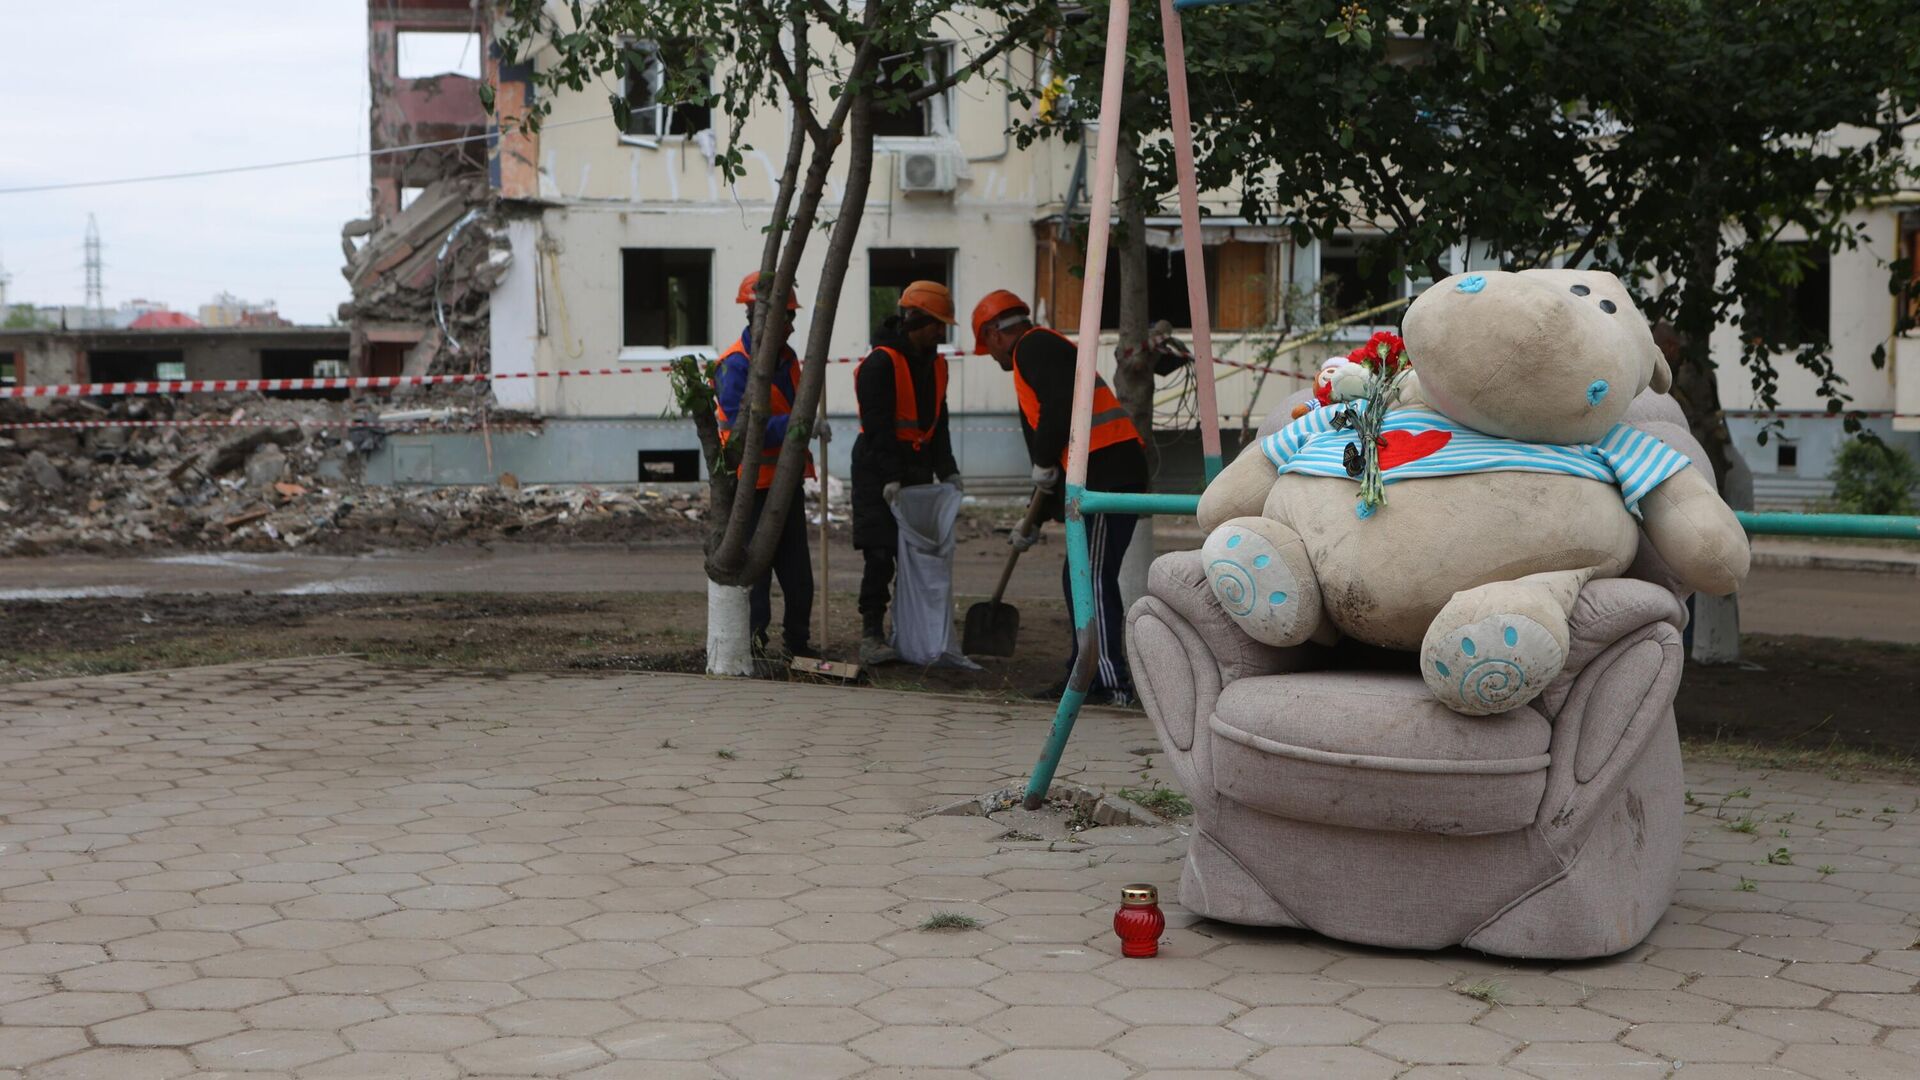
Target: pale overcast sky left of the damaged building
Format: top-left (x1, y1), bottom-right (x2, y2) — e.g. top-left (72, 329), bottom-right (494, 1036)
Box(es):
top-left (0, 0), bottom-right (369, 323)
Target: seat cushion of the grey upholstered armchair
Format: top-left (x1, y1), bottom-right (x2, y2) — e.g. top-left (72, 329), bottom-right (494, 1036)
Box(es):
top-left (1210, 671), bottom-right (1553, 836)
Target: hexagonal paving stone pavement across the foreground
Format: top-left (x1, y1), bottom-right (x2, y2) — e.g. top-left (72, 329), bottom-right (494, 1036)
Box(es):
top-left (0, 659), bottom-right (1920, 1080)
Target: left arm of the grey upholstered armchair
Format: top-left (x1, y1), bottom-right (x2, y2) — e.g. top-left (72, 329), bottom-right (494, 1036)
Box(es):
top-left (1127, 552), bottom-right (1315, 799)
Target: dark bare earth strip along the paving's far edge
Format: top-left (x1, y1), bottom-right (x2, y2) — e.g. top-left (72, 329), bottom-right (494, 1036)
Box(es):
top-left (0, 592), bottom-right (1920, 773)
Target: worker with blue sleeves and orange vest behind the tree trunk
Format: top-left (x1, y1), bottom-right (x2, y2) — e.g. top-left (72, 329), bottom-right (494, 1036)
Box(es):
top-left (714, 271), bottom-right (826, 659)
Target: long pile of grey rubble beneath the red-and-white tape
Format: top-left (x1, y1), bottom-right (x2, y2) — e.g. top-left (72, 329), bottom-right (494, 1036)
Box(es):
top-left (0, 396), bottom-right (707, 555)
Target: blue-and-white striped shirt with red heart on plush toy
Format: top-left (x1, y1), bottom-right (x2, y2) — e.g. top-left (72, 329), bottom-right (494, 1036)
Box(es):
top-left (1260, 402), bottom-right (1692, 517)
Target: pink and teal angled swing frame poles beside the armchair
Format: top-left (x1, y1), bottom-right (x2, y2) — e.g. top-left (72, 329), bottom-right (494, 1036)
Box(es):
top-left (1023, 0), bottom-right (1221, 809)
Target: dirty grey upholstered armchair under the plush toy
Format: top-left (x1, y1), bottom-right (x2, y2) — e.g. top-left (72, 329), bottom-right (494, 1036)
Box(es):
top-left (1127, 394), bottom-right (1711, 959)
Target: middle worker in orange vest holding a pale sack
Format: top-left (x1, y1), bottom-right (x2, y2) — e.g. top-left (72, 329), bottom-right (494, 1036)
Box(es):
top-left (852, 281), bottom-right (962, 663)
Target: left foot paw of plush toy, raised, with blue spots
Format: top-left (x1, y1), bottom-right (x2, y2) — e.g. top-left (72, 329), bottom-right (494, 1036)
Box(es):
top-left (1200, 517), bottom-right (1321, 648)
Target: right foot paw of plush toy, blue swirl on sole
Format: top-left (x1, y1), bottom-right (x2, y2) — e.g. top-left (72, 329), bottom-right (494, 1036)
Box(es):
top-left (1421, 611), bottom-right (1567, 717)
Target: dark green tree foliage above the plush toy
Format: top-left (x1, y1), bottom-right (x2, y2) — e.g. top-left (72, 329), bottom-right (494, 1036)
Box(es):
top-left (1021, 0), bottom-right (1920, 429)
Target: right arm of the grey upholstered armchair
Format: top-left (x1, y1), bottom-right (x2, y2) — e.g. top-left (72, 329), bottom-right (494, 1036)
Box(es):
top-left (1534, 578), bottom-right (1686, 844)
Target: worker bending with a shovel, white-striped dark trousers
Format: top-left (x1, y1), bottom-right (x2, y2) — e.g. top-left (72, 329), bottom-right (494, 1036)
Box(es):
top-left (973, 288), bottom-right (1150, 705)
